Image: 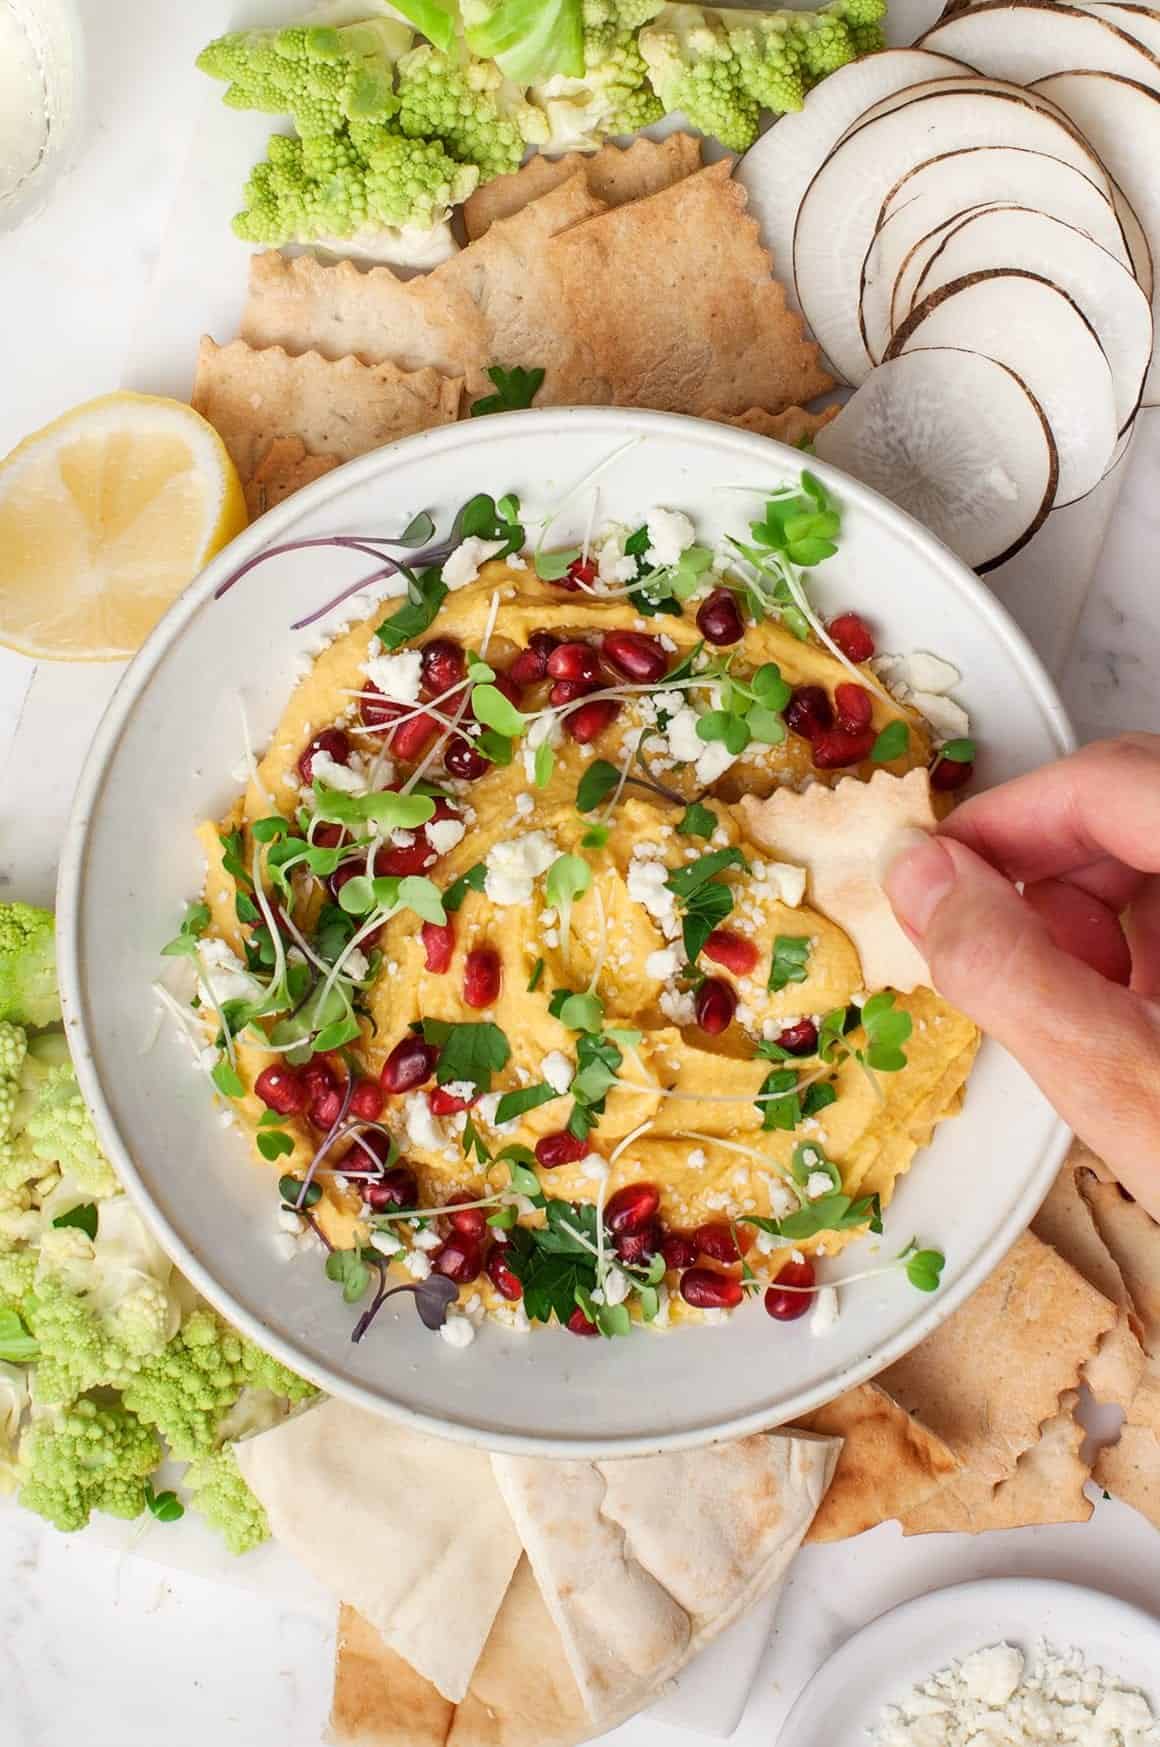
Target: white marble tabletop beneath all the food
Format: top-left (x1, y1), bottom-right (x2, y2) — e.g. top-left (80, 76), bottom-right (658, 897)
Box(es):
top-left (0, 0), bottom-right (1160, 1747)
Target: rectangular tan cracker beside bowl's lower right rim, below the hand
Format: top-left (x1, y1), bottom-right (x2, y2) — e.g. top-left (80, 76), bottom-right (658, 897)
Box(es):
top-left (879, 1232), bottom-right (1116, 1485)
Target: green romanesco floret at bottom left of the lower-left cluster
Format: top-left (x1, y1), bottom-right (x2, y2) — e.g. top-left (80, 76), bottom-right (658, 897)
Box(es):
top-left (17, 1401), bottom-right (161, 1532)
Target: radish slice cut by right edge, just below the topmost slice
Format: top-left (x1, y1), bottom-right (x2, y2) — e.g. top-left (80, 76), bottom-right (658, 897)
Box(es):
top-left (1036, 72), bottom-right (1160, 407)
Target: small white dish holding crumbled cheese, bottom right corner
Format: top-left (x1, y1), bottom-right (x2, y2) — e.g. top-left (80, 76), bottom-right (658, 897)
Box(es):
top-left (777, 1578), bottom-right (1160, 1747)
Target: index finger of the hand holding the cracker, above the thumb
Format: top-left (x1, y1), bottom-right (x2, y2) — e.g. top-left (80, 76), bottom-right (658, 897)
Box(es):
top-left (940, 734), bottom-right (1160, 880)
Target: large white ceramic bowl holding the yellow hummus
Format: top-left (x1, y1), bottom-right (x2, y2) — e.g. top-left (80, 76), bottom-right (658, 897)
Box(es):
top-left (58, 409), bottom-right (1069, 1455)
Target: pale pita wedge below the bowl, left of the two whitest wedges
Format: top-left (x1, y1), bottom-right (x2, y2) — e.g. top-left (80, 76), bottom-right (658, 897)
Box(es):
top-left (238, 1399), bottom-right (521, 1703)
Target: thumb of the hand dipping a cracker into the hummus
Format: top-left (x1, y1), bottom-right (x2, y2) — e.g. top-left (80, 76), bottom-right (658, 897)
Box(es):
top-left (886, 837), bottom-right (1160, 1212)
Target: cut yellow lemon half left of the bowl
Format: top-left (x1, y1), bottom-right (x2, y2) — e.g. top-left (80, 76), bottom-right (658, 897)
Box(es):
top-left (0, 393), bottom-right (246, 660)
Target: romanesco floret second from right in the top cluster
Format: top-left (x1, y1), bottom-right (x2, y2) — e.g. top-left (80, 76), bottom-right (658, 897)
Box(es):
top-left (638, 5), bottom-right (760, 152)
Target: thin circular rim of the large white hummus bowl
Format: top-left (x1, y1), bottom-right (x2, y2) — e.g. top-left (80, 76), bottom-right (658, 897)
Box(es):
top-left (56, 407), bottom-right (1076, 1459)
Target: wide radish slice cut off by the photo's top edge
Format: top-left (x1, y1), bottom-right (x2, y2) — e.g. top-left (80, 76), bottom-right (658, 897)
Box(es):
top-left (921, 0), bottom-right (1160, 89)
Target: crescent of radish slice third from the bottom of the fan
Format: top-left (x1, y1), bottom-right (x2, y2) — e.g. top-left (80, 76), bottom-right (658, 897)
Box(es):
top-left (915, 206), bottom-right (1153, 432)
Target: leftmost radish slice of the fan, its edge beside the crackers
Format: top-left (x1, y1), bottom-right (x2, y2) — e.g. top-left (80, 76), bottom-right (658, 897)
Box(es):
top-left (735, 49), bottom-right (968, 309)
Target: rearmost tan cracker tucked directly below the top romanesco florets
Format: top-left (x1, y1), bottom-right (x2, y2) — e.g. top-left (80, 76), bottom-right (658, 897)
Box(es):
top-left (463, 133), bottom-right (701, 243)
